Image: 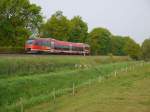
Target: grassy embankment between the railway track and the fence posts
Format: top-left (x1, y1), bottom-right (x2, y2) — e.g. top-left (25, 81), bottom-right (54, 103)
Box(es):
top-left (0, 56), bottom-right (133, 112)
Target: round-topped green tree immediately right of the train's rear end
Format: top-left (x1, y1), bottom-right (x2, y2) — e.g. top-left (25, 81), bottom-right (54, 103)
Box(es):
top-left (88, 28), bottom-right (111, 55)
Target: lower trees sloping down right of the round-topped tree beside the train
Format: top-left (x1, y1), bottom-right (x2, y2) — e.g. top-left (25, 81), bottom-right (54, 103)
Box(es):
top-left (111, 36), bottom-right (141, 59)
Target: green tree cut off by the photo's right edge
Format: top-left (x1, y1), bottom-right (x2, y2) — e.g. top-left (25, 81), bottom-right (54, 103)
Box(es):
top-left (142, 38), bottom-right (150, 60)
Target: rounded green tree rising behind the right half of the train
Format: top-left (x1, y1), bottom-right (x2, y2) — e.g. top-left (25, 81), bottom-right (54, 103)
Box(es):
top-left (69, 16), bottom-right (88, 42)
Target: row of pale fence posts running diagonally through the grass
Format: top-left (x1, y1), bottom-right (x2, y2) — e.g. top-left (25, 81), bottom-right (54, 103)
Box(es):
top-left (5, 62), bottom-right (150, 112)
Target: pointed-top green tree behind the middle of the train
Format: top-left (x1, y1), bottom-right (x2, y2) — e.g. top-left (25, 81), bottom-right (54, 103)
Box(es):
top-left (42, 11), bottom-right (70, 40)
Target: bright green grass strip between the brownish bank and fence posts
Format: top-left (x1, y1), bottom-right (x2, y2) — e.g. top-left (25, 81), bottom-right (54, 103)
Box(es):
top-left (0, 62), bottom-right (135, 111)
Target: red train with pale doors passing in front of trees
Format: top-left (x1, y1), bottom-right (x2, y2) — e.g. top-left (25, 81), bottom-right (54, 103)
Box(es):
top-left (25, 38), bottom-right (90, 55)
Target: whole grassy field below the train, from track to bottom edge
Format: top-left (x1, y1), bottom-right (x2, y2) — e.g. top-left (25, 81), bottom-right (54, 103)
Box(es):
top-left (0, 55), bottom-right (150, 112)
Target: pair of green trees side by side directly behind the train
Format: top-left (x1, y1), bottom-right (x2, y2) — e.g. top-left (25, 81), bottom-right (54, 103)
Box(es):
top-left (41, 11), bottom-right (88, 42)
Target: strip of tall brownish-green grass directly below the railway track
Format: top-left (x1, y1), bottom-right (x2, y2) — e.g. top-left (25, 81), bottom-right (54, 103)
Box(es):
top-left (0, 55), bottom-right (130, 78)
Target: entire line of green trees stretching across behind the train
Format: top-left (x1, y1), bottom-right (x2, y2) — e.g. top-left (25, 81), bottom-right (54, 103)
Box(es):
top-left (0, 0), bottom-right (150, 59)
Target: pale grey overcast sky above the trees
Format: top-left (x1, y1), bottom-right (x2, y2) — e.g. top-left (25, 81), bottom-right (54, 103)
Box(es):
top-left (30, 0), bottom-right (150, 44)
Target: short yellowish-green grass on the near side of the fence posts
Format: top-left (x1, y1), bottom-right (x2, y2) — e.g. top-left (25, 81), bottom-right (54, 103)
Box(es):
top-left (26, 64), bottom-right (150, 112)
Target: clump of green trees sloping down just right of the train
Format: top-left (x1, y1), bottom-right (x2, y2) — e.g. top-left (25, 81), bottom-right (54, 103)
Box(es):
top-left (88, 28), bottom-right (141, 59)
